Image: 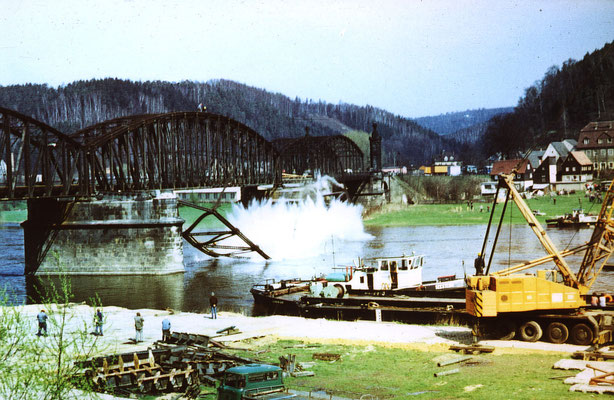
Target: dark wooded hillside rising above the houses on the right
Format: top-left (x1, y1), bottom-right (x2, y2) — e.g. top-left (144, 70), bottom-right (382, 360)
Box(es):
top-left (482, 42), bottom-right (614, 157)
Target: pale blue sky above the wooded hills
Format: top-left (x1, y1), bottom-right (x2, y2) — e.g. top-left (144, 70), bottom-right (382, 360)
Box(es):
top-left (0, 0), bottom-right (614, 118)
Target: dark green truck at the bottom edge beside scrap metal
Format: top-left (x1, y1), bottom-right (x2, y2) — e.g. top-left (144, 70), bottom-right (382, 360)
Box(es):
top-left (217, 364), bottom-right (305, 400)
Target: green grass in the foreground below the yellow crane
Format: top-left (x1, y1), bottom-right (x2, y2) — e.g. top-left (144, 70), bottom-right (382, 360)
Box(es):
top-left (223, 340), bottom-right (590, 400)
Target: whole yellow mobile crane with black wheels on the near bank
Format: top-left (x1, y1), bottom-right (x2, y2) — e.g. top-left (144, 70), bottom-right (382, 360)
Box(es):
top-left (466, 172), bottom-right (614, 345)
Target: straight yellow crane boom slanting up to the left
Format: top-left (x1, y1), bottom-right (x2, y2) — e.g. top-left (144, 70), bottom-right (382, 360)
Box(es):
top-left (493, 172), bottom-right (578, 287)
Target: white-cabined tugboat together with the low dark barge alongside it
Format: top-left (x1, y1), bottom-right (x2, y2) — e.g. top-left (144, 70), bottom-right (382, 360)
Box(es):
top-left (251, 254), bottom-right (467, 323)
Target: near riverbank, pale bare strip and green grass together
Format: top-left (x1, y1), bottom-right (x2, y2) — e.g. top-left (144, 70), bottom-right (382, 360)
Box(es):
top-left (6, 304), bottom-right (582, 399)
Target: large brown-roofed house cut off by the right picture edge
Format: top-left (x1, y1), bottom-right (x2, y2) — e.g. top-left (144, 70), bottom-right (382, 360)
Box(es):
top-left (577, 121), bottom-right (614, 175)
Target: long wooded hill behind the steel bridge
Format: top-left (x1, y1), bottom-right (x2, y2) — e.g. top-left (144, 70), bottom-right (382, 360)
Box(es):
top-left (0, 79), bottom-right (452, 165)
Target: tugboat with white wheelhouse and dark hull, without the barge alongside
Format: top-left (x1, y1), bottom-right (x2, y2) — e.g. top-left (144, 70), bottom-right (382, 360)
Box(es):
top-left (251, 253), bottom-right (465, 313)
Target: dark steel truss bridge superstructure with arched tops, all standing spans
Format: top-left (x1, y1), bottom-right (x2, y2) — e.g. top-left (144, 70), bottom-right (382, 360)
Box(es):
top-left (0, 107), bottom-right (364, 200)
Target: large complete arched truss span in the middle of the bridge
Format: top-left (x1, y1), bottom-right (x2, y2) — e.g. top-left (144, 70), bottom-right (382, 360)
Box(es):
top-left (84, 112), bottom-right (281, 191)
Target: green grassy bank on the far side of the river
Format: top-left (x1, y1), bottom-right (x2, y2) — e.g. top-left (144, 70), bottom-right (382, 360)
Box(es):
top-left (365, 193), bottom-right (601, 226)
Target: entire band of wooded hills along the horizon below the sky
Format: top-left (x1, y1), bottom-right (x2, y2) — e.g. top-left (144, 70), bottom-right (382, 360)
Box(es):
top-left (0, 38), bottom-right (614, 167)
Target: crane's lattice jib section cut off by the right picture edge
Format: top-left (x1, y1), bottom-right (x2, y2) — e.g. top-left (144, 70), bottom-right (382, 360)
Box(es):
top-left (578, 180), bottom-right (614, 294)
